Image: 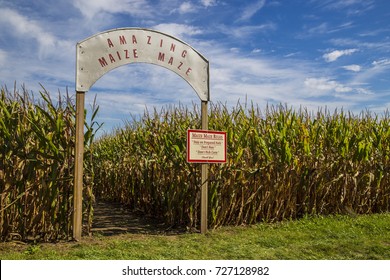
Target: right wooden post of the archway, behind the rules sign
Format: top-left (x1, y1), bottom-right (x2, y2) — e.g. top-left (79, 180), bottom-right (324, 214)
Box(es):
top-left (200, 101), bottom-right (209, 234)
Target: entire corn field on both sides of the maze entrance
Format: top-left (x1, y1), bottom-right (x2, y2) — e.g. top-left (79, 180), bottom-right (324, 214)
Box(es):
top-left (0, 85), bottom-right (390, 241)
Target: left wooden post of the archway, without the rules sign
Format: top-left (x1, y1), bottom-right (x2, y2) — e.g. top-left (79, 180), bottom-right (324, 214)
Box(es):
top-left (73, 91), bottom-right (85, 241)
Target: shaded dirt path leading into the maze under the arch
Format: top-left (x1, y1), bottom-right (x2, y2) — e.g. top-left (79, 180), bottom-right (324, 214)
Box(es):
top-left (92, 201), bottom-right (177, 235)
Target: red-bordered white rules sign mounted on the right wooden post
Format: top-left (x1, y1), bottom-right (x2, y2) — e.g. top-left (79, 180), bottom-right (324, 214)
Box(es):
top-left (187, 129), bottom-right (227, 163)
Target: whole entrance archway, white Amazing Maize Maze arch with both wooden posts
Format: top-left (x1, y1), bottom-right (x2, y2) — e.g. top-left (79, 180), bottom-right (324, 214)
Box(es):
top-left (73, 28), bottom-right (210, 240)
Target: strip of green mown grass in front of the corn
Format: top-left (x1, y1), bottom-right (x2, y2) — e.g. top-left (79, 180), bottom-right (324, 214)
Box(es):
top-left (0, 214), bottom-right (390, 260)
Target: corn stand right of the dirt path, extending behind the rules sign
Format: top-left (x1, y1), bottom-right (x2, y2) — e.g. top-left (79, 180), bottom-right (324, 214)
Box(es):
top-left (93, 103), bottom-right (390, 228)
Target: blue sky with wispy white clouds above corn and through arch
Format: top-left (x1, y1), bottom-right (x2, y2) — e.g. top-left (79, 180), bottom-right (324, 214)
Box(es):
top-left (0, 0), bottom-right (390, 132)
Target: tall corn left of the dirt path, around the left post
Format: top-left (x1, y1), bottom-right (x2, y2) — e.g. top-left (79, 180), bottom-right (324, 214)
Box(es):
top-left (0, 88), bottom-right (97, 241)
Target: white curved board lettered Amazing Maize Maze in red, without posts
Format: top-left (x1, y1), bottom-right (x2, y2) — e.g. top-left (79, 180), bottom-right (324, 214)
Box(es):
top-left (76, 28), bottom-right (209, 101)
